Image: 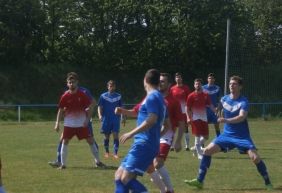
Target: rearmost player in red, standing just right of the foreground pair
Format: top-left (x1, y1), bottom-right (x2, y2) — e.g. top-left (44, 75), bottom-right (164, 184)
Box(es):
top-left (170, 72), bottom-right (191, 151)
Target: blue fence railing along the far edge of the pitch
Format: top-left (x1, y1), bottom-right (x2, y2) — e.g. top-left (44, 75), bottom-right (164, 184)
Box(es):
top-left (0, 102), bottom-right (282, 122)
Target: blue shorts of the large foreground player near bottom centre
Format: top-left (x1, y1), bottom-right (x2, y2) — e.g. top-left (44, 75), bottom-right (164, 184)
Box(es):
top-left (121, 144), bottom-right (158, 176)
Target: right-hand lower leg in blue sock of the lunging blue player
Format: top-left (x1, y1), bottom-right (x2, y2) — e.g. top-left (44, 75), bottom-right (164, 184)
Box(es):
top-left (247, 149), bottom-right (273, 189)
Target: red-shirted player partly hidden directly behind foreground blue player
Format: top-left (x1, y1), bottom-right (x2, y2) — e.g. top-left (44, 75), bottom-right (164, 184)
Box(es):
top-left (148, 73), bottom-right (186, 193)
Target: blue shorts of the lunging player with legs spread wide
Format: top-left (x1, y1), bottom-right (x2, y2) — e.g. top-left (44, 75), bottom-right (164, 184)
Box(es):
top-left (212, 134), bottom-right (256, 152)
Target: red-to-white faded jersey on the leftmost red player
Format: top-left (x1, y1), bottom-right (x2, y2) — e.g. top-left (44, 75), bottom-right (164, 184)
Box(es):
top-left (59, 89), bottom-right (91, 127)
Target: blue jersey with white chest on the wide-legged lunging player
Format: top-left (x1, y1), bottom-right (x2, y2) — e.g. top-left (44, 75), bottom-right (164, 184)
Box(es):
top-left (220, 95), bottom-right (250, 139)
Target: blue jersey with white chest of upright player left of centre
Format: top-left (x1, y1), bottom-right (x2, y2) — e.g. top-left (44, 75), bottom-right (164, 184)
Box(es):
top-left (98, 92), bottom-right (122, 122)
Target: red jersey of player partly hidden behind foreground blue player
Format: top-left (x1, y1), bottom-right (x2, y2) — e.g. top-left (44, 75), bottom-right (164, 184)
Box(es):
top-left (164, 94), bottom-right (185, 131)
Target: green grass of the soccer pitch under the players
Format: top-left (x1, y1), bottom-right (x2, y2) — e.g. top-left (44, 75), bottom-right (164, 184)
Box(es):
top-left (0, 120), bottom-right (282, 193)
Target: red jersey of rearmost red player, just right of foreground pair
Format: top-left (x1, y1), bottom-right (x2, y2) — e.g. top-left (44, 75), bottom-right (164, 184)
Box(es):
top-left (170, 85), bottom-right (191, 114)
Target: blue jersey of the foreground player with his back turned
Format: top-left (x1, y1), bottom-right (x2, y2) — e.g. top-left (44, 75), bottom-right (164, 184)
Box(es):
top-left (134, 90), bottom-right (166, 152)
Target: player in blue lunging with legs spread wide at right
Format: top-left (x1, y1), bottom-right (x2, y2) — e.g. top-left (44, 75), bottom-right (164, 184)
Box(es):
top-left (185, 76), bottom-right (273, 190)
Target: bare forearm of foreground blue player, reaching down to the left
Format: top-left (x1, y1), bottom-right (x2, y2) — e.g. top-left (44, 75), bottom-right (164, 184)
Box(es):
top-left (119, 113), bottom-right (158, 143)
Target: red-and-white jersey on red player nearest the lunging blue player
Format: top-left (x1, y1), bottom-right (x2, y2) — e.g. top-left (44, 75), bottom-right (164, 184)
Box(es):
top-left (187, 92), bottom-right (211, 121)
